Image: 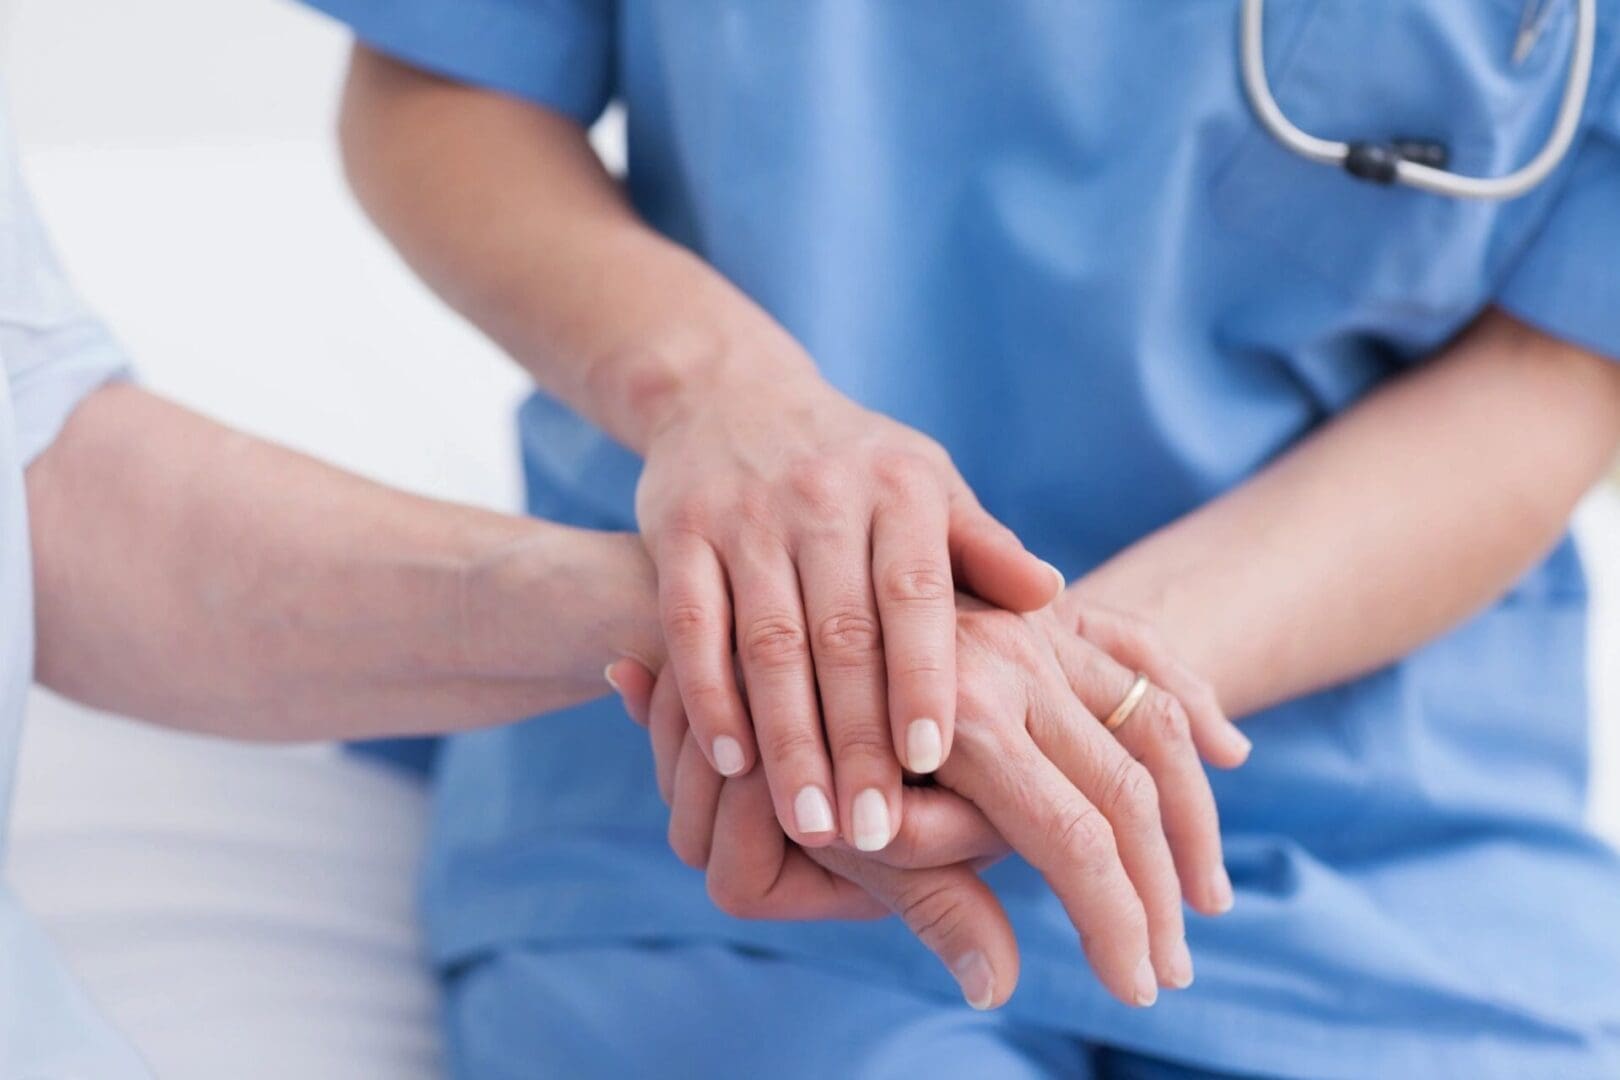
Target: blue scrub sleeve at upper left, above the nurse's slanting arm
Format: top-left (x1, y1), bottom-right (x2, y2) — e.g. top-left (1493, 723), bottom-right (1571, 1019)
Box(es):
top-left (306, 0), bottom-right (616, 126)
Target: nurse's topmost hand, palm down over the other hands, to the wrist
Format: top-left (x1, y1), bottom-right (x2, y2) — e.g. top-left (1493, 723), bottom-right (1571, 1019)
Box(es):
top-left (637, 377), bottom-right (1061, 850)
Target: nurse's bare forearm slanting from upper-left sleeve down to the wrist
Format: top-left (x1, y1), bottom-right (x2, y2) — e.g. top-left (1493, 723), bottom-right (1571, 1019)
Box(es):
top-left (342, 47), bottom-right (815, 452)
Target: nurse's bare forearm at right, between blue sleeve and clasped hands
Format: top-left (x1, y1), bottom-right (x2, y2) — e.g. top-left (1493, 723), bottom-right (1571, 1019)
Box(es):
top-left (1074, 313), bottom-right (1620, 716)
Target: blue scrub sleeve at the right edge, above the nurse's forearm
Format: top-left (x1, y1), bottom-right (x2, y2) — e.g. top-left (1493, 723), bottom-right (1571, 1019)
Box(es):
top-left (1495, 78), bottom-right (1620, 361)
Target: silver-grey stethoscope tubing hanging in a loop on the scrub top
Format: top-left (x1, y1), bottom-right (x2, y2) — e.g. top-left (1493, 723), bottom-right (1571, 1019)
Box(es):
top-left (1239, 0), bottom-right (1597, 199)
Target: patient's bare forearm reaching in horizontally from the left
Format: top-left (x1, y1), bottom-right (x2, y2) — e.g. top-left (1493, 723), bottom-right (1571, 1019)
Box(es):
top-left (28, 387), bottom-right (659, 740)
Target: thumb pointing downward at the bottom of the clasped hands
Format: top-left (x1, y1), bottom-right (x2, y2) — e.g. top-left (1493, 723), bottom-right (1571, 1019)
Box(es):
top-left (805, 847), bottom-right (1019, 1009)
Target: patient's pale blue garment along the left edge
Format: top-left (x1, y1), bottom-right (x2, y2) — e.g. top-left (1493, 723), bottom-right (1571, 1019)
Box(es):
top-left (0, 96), bottom-right (147, 1080)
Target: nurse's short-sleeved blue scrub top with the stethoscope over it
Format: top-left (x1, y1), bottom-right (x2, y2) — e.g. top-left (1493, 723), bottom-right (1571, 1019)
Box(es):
top-left (306, 0), bottom-right (1620, 1077)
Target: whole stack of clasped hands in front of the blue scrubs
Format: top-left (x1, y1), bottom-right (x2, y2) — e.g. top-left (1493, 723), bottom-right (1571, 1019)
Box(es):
top-left (614, 374), bottom-right (1247, 1007)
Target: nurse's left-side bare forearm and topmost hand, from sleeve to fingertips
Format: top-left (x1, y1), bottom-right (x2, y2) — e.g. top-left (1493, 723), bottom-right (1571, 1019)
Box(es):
top-left (332, 49), bottom-right (1059, 850)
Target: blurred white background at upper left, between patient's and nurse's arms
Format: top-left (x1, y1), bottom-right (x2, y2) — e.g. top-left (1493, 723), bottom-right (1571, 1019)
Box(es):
top-left (5, 0), bottom-right (525, 507)
